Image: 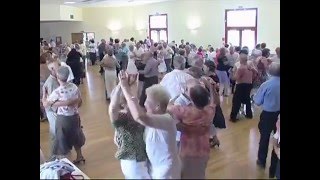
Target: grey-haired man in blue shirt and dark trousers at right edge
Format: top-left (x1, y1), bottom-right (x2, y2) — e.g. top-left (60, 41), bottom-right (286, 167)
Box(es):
top-left (253, 63), bottom-right (280, 168)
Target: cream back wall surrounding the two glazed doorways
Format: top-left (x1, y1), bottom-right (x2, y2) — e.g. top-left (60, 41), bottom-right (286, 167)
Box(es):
top-left (40, 0), bottom-right (280, 50)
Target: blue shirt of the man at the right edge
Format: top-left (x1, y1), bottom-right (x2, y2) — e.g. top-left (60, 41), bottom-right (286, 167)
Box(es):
top-left (253, 77), bottom-right (280, 112)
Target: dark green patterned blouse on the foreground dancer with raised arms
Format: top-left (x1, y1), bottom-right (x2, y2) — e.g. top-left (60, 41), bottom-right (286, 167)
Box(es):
top-left (113, 112), bottom-right (147, 162)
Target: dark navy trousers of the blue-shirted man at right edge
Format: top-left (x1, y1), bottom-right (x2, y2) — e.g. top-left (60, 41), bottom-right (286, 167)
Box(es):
top-left (258, 111), bottom-right (280, 165)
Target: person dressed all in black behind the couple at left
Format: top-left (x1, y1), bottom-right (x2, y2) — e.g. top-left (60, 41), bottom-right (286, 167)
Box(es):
top-left (66, 48), bottom-right (82, 86)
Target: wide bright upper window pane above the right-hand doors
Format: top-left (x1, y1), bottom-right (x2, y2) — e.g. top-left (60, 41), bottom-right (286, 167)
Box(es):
top-left (227, 10), bottom-right (256, 27)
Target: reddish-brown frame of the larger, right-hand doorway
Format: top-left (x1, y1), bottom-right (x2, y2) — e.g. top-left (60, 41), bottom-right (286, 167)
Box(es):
top-left (224, 8), bottom-right (258, 47)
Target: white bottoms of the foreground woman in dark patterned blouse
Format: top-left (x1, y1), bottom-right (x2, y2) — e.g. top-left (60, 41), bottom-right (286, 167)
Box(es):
top-left (120, 160), bottom-right (151, 179)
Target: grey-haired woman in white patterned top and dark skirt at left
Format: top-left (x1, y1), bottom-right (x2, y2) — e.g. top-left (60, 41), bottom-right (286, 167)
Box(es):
top-left (43, 66), bottom-right (85, 164)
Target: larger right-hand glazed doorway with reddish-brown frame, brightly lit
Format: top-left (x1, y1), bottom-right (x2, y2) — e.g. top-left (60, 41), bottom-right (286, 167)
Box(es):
top-left (225, 8), bottom-right (258, 49)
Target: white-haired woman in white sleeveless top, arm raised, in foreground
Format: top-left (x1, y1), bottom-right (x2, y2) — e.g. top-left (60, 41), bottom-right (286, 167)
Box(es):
top-left (119, 72), bottom-right (181, 179)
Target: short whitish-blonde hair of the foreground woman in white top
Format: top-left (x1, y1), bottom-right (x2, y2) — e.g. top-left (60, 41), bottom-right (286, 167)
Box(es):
top-left (146, 84), bottom-right (170, 110)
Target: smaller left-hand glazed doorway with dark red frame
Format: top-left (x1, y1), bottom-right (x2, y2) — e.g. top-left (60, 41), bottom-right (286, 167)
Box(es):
top-left (149, 14), bottom-right (168, 42)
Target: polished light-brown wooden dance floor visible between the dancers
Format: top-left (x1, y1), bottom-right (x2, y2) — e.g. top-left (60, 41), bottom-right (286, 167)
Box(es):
top-left (40, 66), bottom-right (271, 179)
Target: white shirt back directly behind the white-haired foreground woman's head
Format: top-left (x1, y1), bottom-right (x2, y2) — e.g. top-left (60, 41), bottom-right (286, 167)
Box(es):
top-left (160, 69), bottom-right (193, 99)
